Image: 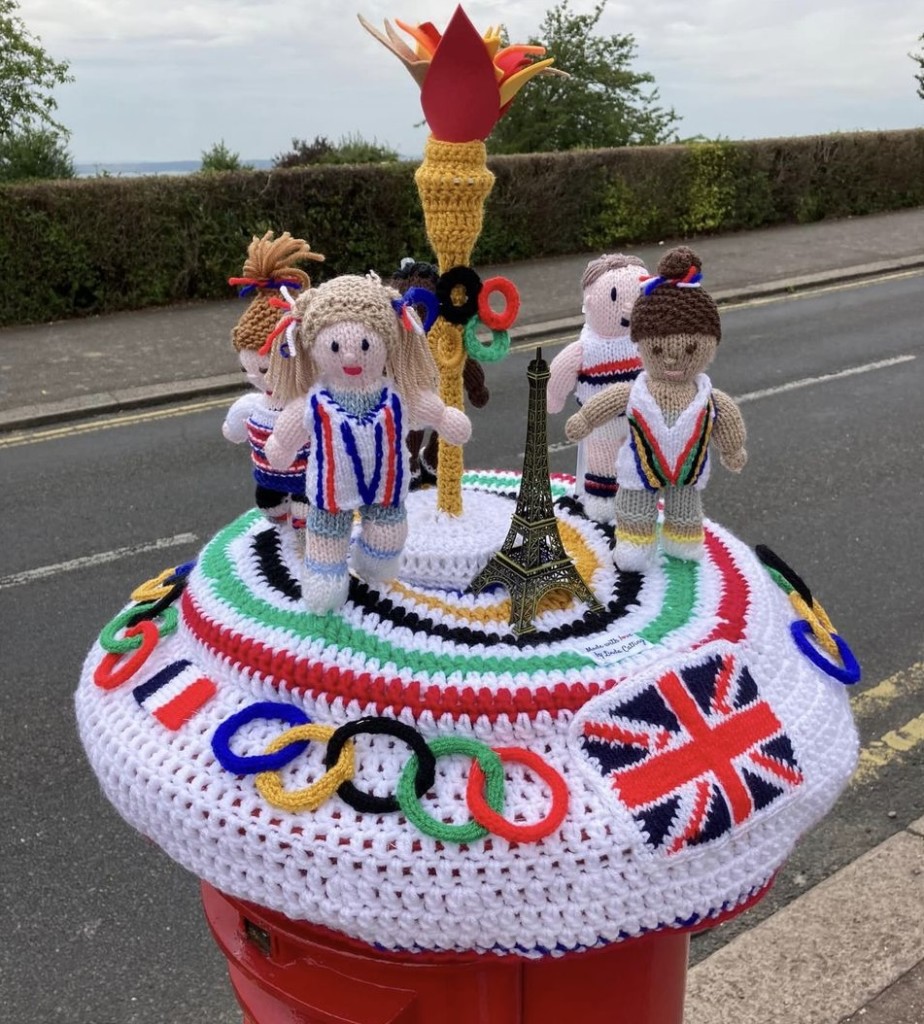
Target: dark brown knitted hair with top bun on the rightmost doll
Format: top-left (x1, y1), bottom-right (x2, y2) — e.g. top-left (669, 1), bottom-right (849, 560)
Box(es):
top-left (630, 246), bottom-right (722, 343)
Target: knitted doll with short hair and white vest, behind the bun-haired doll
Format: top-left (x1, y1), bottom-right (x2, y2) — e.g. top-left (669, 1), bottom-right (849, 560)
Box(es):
top-left (547, 253), bottom-right (647, 522)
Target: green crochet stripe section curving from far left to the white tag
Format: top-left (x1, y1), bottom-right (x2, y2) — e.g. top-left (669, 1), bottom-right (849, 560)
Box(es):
top-left (199, 510), bottom-right (596, 675)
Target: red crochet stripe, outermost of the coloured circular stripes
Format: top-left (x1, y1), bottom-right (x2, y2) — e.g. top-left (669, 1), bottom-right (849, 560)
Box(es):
top-left (182, 532), bottom-right (749, 722)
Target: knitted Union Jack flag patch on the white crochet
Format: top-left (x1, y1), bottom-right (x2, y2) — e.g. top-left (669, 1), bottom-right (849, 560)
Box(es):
top-left (572, 644), bottom-right (803, 855)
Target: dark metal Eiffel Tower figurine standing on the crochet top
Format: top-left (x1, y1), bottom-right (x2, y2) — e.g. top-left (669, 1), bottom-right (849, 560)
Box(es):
top-left (469, 348), bottom-right (601, 636)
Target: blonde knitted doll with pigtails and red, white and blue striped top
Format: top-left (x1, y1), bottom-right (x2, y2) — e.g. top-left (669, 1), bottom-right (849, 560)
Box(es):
top-left (266, 275), bottom-right (471, 613)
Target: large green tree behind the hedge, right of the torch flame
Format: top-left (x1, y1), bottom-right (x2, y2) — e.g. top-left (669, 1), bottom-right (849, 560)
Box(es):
top-left (488, 0), bottom-right (680, 153)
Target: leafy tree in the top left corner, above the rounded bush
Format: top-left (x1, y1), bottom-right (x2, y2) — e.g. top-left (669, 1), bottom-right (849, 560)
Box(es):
top-left (0, 0), bottom-right (73, 139)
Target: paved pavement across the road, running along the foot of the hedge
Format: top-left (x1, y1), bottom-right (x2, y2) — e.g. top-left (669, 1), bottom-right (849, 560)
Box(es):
top-left (0, 208), bottom-right (924, 431)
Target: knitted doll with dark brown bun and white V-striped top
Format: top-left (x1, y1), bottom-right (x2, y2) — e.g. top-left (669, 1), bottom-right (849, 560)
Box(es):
top-left (565, 246), bottom-right (747, 570)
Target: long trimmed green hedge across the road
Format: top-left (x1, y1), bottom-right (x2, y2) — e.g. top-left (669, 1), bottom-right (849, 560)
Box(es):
top-left (0, 129), bottom-right (924, 325)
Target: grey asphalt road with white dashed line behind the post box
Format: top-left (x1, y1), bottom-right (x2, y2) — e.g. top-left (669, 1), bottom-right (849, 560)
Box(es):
top-left (0, 274), bottom-right (924, 1024)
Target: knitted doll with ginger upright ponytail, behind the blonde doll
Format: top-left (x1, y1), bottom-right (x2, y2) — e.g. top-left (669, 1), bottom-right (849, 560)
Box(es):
top-left (221, 231), bottom-right (324, 529)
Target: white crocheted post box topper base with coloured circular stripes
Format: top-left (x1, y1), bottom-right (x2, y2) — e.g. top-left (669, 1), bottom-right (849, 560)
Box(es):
top-left (77, 473), bottom-right (857, 957)
